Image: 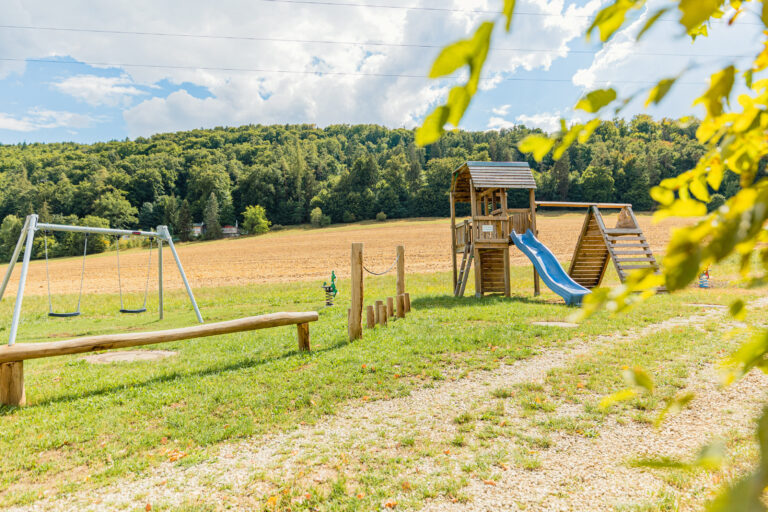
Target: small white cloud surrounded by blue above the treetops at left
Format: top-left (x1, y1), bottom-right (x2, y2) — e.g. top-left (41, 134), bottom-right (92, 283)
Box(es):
top-left (53, 75), bottom-right (146, 107)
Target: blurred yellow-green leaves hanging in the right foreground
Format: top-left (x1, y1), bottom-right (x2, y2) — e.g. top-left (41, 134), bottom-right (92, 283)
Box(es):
top-left (424, 0), bottom-right (768, 510)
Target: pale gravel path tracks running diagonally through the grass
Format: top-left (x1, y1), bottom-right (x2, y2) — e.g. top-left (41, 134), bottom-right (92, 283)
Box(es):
top-left (11, 297), bottom-right (768, 511)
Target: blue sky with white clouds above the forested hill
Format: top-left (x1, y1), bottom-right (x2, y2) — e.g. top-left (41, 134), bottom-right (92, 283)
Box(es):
top-left (0, 0), bottom-right (761, 144)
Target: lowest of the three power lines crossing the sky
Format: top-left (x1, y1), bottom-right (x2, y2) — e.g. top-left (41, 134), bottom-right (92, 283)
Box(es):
top-left (0, 57), bottom-right (706, 85)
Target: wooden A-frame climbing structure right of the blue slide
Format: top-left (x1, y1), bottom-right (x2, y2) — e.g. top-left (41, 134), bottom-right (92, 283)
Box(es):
top-left (568, 205), bottom-right (660, 288)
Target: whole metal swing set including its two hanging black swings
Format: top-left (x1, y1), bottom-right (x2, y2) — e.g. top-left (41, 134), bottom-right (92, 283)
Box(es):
top-left (0, 214), bottom-right (203, 346)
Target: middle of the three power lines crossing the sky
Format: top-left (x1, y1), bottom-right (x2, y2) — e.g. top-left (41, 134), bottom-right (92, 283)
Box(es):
top-left (0, 24), bottom-right (752, 59)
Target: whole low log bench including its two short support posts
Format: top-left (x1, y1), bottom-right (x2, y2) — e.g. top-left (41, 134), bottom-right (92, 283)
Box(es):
top-left (0, 311), bottom-right (318, 406)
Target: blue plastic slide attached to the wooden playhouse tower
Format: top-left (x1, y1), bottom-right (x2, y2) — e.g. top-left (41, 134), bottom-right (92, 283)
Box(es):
top-left (509, 229), bottom-right (590, 306)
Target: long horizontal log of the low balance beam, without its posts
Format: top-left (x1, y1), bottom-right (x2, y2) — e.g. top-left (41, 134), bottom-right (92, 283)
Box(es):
top-left (0, 311), bottom-right (318, 363)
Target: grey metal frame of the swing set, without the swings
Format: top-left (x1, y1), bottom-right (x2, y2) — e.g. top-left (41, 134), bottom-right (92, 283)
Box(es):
top-left (0, 214), bottom-right (203, 346)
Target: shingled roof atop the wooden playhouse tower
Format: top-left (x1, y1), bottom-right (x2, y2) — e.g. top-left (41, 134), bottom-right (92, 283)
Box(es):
top-left (451, 162), bottom-right (536, 202)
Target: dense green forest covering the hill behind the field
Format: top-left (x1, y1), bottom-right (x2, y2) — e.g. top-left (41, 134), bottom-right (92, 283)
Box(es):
top-left (0, 115), bottom-right (752, 258)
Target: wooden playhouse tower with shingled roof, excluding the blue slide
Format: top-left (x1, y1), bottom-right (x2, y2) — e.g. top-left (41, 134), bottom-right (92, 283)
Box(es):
top-left (451, 162), bottom-right (539, 297)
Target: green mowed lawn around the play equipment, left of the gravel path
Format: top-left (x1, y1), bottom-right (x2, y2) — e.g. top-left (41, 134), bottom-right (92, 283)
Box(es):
top-left (0, 256), bottom-right (756, 505)
